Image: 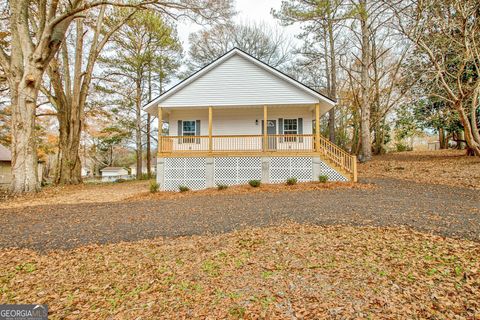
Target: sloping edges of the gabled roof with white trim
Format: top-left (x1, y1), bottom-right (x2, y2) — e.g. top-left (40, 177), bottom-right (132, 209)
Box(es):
top-left (144, 48), bottom-right (335, 114)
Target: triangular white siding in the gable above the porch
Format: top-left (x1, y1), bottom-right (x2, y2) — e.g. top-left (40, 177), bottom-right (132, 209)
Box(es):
top-left (160, 54), bottom-right (319, 107)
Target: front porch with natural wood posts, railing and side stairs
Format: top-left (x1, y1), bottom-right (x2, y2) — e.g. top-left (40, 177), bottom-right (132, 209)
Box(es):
top-left (158, 104), bottom-right (357, 181)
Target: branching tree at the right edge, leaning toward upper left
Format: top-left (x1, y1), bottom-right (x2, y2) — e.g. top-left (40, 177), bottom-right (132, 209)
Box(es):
top-left (392, 0), bottom-right (480, 156)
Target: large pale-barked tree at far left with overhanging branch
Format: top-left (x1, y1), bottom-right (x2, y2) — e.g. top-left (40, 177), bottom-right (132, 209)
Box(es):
top-left (0, 0), bottom-right (230, 193)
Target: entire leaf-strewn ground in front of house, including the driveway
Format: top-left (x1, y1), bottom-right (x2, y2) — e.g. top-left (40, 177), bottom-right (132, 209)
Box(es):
top-left (0, 151), bottom-right (480, 320)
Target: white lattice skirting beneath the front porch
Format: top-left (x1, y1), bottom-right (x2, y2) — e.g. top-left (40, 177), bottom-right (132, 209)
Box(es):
top-left (157, 157), bottom-right (349, 191)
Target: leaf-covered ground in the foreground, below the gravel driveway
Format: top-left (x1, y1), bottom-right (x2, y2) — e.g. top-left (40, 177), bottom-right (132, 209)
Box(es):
top-left (0, 224), bottom-right (480, 319)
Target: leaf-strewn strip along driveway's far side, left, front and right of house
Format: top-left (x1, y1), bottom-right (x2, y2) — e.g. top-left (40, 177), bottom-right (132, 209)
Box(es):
top-left (0, 150), bottom-right (480, 209)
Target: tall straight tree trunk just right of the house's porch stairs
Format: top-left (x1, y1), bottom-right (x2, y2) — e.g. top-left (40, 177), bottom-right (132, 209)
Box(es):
top-left (359, 0), bottom-right (372, 161)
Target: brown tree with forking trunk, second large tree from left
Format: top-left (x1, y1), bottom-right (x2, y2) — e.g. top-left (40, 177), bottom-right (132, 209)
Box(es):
top-left (41, 6), bottom-right (136, 184)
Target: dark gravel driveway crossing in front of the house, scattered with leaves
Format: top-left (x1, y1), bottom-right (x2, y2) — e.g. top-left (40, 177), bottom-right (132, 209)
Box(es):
top-left (0, 179), bottom-right (480, 251)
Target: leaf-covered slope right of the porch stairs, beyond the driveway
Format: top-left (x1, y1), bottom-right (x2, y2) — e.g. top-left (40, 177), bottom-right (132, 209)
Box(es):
top-left (358, 150), bottom-right (480, 189)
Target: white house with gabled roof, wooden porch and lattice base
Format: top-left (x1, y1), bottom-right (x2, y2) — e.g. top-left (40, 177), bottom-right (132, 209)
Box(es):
top-left (145, 49), bottom-right (356, 190)
